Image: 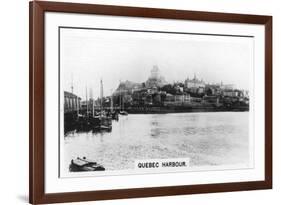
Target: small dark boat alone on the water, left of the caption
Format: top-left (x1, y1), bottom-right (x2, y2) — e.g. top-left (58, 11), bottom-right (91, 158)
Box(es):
top-left (69, 157), bottom-right (105, 172)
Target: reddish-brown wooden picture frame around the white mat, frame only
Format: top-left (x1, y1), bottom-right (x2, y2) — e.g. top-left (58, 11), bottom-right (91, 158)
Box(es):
top-left (29, 1), bottom-right (272, 204)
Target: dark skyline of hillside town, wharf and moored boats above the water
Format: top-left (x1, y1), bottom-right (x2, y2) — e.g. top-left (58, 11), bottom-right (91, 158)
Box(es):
top-left (64, 65), bottom-right (249, 131)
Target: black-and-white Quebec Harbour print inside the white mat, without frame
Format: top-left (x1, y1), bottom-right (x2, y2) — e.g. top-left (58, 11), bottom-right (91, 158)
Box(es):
top-left (58, 27), bottom-right (254, 177)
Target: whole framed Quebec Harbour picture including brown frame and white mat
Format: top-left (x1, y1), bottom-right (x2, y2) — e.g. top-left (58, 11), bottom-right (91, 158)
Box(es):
top-left (30, 1), bottom-right (272, 204)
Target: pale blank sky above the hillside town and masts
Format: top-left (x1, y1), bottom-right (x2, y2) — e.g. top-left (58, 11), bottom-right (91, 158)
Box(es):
top-left (60, 28), bottom-right (254, 98)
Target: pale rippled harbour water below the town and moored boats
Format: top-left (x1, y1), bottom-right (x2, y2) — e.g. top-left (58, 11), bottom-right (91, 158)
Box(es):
top-left (63, 112), bottom-right (249, 171)
